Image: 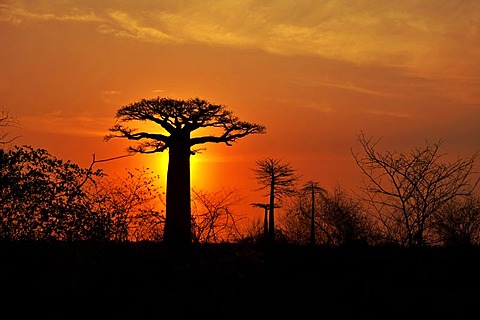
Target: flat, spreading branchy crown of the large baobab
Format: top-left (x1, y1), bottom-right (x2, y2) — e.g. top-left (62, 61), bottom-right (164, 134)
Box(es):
top-left (106, 97), bottom-right (266, 154)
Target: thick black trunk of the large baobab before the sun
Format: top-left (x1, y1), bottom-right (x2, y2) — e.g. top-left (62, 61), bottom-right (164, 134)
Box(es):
top-left (164, 139), bottom-right (192, 246)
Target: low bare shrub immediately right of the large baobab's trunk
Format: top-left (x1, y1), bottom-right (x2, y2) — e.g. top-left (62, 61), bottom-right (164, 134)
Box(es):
top-left (192, 189), bottom-right (242, 243)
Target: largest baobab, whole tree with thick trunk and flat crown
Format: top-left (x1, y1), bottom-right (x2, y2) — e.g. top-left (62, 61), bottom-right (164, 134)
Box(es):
top-left (105, 97), bottom-right (266, 246)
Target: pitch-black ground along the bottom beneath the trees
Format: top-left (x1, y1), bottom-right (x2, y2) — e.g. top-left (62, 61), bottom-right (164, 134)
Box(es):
top-left (0, 242), bottom-right (480, 319)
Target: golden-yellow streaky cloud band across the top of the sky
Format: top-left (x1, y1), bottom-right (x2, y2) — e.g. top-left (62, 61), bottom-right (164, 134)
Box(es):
top-left (0, 0), bottom-right (480, 78)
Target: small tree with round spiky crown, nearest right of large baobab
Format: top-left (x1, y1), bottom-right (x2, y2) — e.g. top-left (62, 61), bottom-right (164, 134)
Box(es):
top-left (253, 157), bottom-right (299, 242)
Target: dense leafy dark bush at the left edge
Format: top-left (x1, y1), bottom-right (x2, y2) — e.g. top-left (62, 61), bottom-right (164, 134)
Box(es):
top-left (0, 146), bottom-right (105, 240)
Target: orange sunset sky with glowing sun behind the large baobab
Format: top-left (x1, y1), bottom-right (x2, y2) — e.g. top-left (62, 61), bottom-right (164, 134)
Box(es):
top-left (0, 0), bottom-right (480, 217)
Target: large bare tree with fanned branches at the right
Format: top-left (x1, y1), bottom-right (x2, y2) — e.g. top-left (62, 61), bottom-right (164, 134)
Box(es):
top-left (352, 133), bottom-right (478, 246)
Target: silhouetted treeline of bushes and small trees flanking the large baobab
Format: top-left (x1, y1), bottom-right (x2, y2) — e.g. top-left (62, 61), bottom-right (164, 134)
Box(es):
top-left (0, 108), bottom-right (480, 247)
